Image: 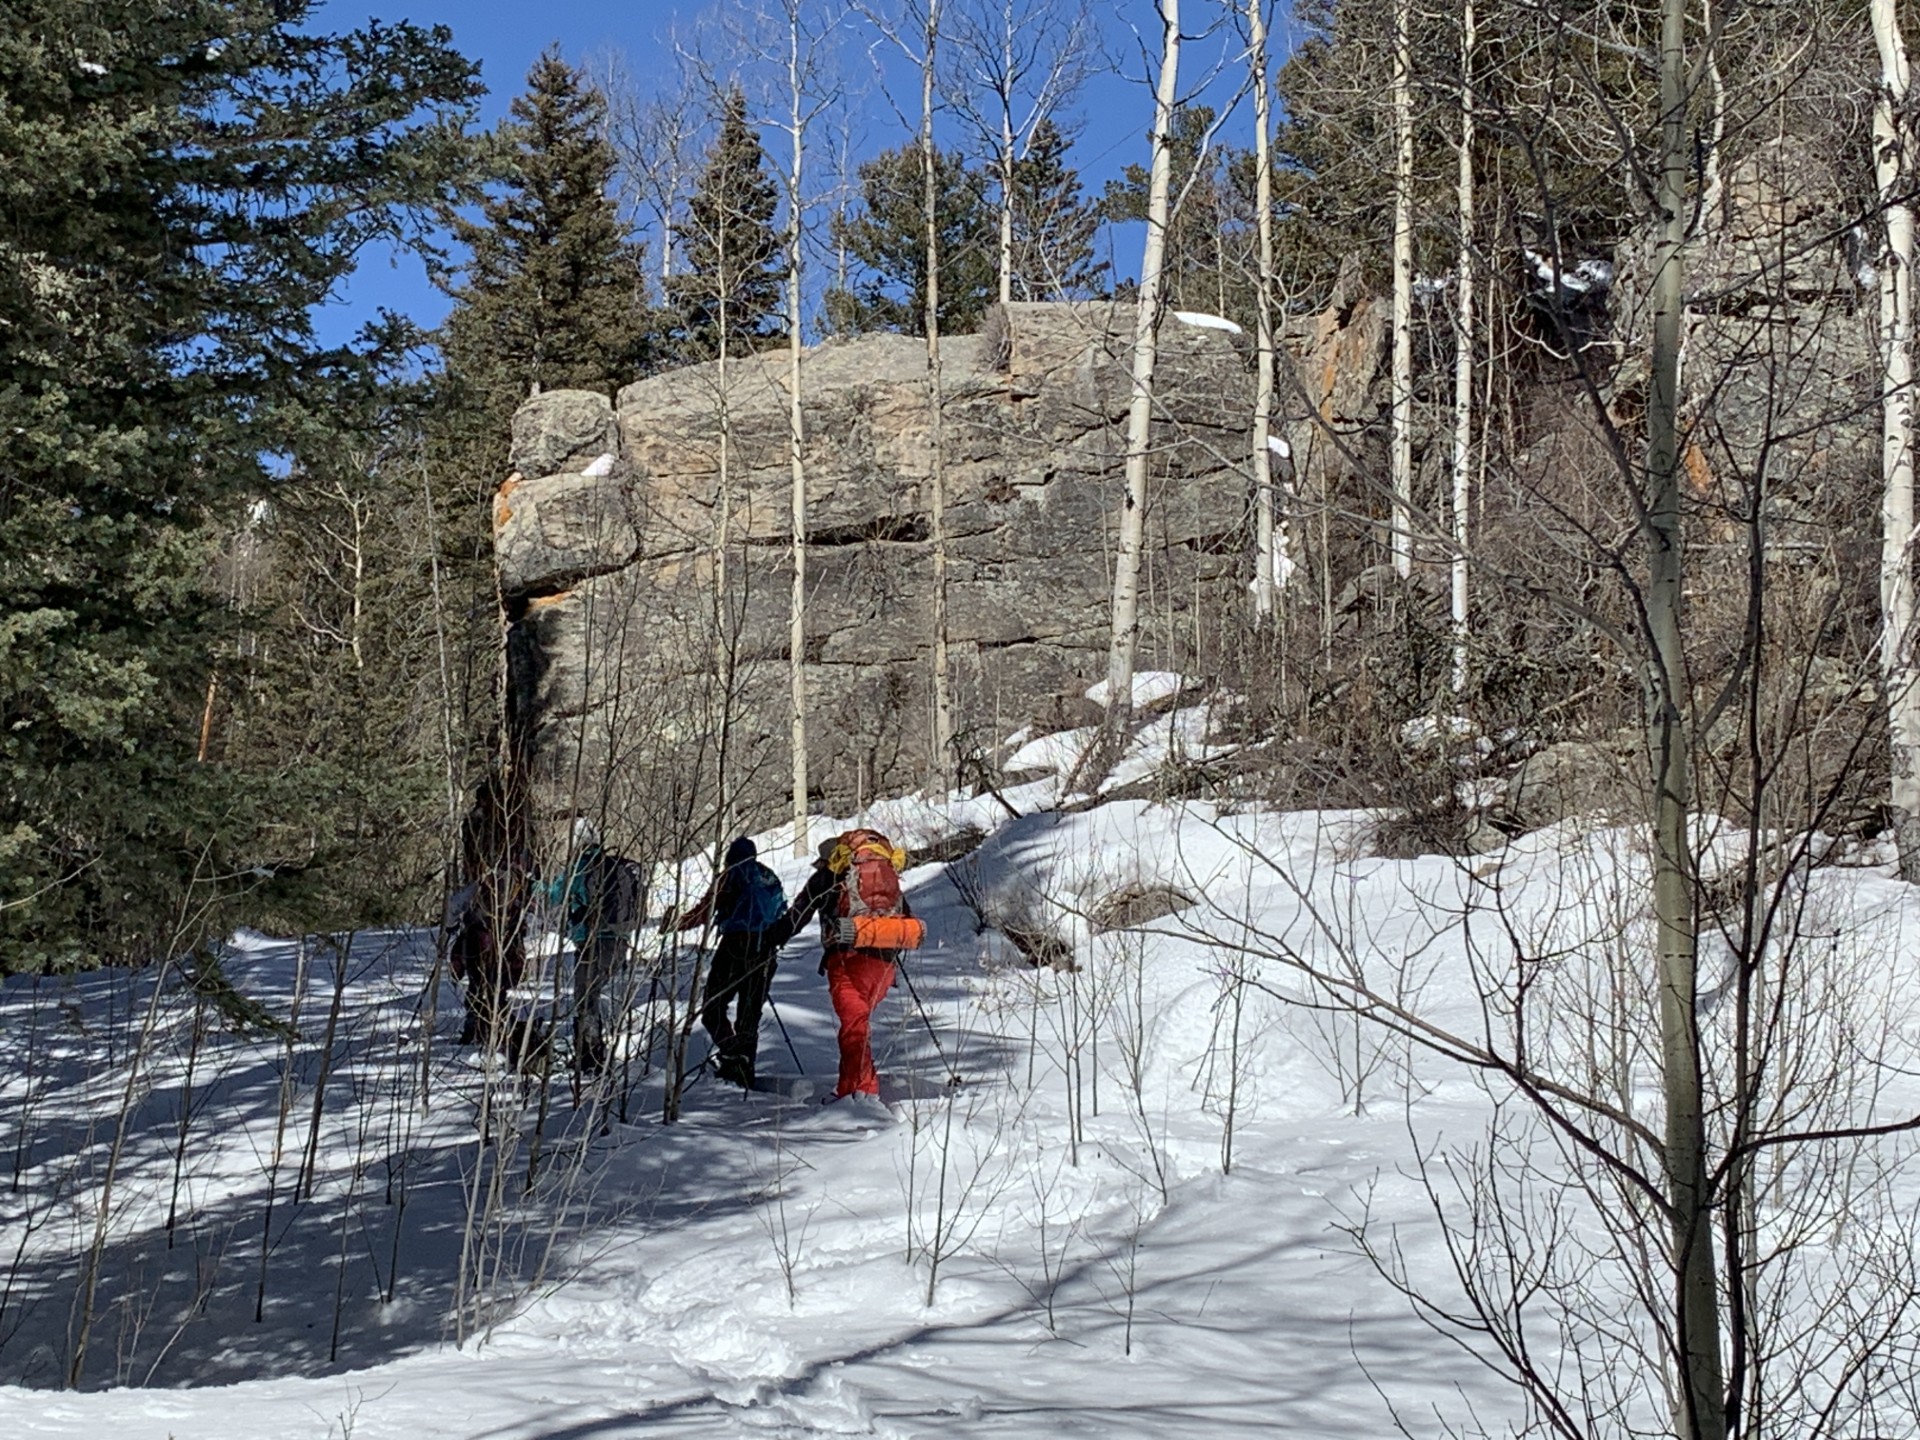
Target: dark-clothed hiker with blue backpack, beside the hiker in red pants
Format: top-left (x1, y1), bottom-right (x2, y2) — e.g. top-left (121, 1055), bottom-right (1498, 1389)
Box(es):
top-left (680, 835), bottom-right (787, 1089)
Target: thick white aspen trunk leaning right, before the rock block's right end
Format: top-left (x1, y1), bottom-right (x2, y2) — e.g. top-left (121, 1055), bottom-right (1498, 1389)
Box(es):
top-left (1094, 0), bottom-right (1181, 756)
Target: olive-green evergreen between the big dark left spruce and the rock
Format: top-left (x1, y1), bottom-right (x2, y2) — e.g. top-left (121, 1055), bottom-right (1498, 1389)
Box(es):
top-left (215, 372), bottom-right (463, 933)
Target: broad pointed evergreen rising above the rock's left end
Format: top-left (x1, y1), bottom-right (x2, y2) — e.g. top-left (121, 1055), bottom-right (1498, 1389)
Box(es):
top-left (444, 50), bottom-right (655, 408)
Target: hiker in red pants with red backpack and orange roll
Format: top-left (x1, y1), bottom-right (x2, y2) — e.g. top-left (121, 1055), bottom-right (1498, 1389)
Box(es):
top-left (768, 829), bottom-right (912, 1098)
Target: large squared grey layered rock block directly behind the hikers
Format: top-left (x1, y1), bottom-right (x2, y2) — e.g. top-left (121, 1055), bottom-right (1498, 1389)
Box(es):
top-left (495, 301), bottom-right (1252, 820)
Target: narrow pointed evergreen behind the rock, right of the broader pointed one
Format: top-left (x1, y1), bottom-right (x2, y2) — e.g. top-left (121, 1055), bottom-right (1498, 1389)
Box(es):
top-left (666, 90), bottom-right (785, 363)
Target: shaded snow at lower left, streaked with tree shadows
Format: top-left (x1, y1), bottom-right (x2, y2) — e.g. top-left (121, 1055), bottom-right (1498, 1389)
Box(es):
top-left (0, 937), bottom-right (810, 1388)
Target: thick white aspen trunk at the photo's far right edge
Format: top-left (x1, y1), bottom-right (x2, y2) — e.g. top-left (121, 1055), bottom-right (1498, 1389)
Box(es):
top-left (1870, 0), bottom-right (1920, 881)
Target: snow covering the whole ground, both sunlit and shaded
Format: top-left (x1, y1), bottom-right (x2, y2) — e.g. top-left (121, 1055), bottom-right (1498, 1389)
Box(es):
top-left (0, 712), bottom-right (1920, 1440)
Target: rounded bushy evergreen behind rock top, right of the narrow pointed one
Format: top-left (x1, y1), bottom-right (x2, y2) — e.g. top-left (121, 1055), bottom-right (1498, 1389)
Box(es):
top-left (828, 144), bottom-right (998, 334)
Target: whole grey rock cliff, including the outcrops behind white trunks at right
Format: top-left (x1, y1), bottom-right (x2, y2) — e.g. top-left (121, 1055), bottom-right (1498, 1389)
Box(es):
top-left (483, 144), bottom-right (1878, 844)
